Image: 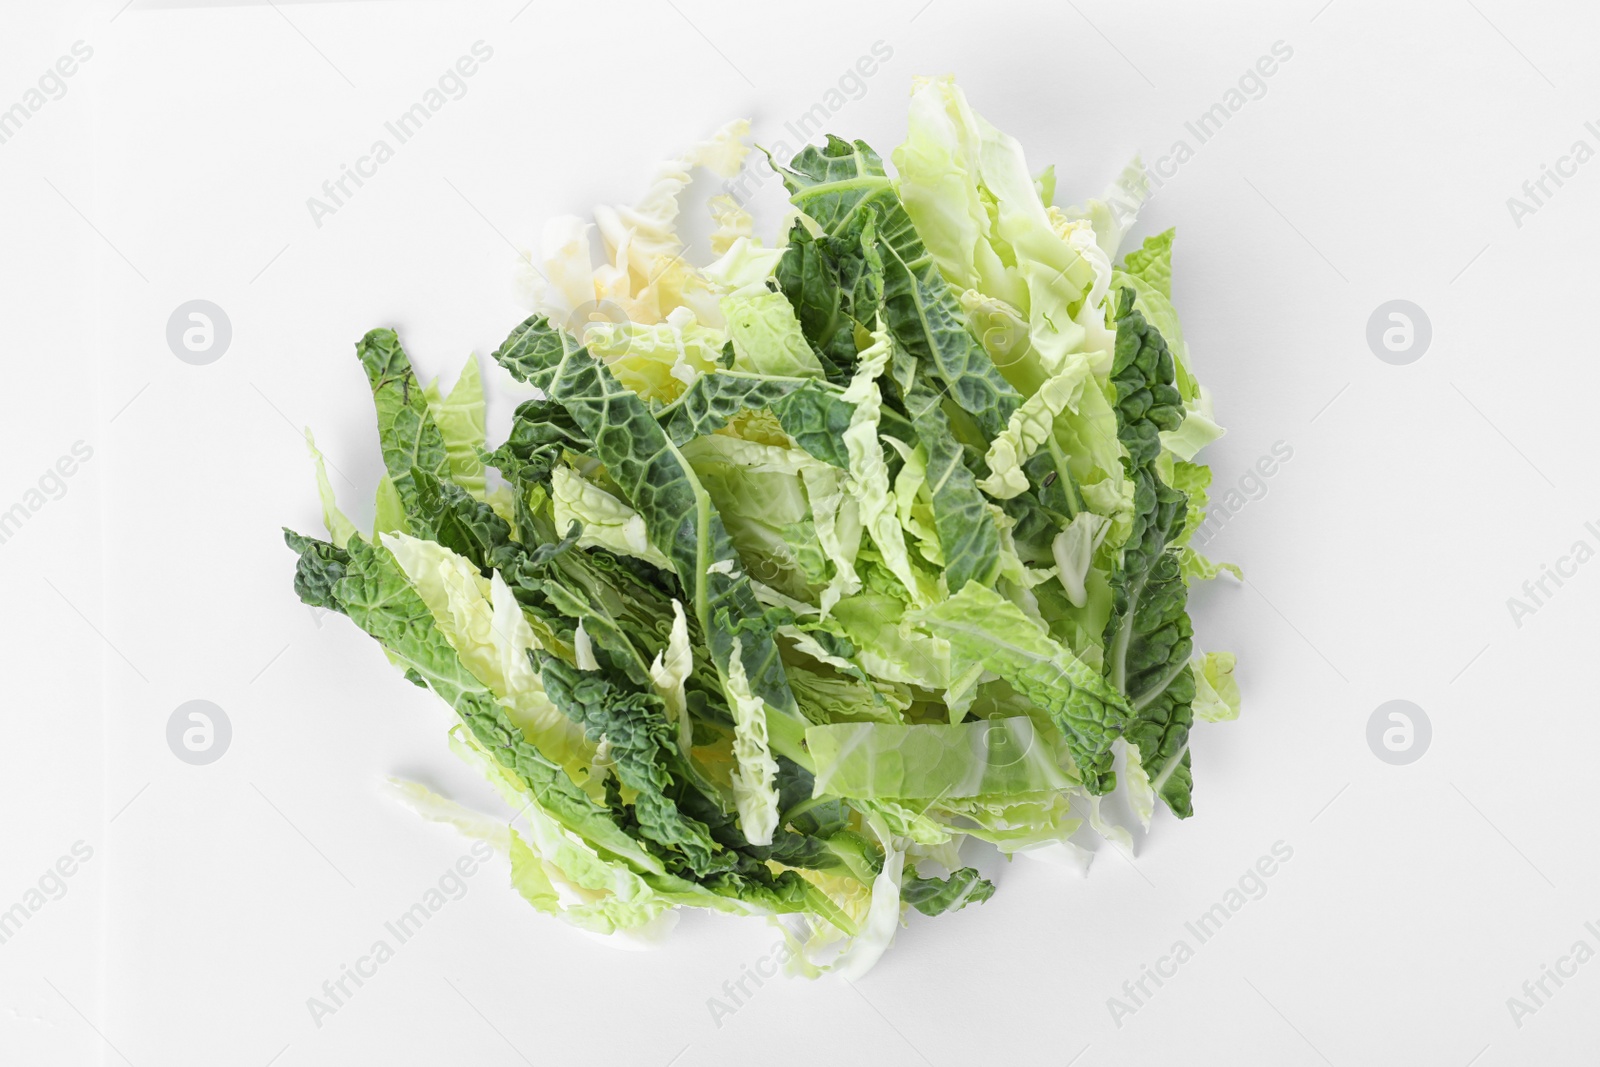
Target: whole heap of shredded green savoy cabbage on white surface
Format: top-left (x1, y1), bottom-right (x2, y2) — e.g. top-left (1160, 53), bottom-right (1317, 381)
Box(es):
top-left (285, 78), bottom-right (1240, 977)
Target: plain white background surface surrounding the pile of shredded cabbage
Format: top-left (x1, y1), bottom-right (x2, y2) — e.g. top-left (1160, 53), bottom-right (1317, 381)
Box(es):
top-left (0, 0), bottom-right (1600, 1067)
